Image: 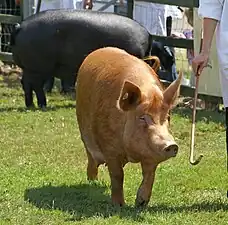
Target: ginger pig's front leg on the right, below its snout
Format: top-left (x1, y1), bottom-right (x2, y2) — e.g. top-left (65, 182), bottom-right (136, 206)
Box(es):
top-left (135, 162), bottom-right (157, 206)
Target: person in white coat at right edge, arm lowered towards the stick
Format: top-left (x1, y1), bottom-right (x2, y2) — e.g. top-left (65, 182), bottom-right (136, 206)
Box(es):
top-left (192, 0), bottom-right (228, 168)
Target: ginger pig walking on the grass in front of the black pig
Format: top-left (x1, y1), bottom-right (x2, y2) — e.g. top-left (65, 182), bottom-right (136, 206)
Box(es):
top-left (76, 47), bottom-right (182, 206)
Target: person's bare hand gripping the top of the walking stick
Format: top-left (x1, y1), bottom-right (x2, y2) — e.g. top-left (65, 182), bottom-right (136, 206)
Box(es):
top-left (192, 53), bottom-right (209, 76)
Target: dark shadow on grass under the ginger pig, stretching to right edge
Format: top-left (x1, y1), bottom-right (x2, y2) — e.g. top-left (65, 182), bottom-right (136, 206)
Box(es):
top-left (24, 183), bottom-right (228, 221)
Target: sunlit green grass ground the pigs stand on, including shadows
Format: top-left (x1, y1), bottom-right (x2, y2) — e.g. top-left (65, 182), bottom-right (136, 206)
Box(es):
top-left (0, 76), bottom-right (228, 225)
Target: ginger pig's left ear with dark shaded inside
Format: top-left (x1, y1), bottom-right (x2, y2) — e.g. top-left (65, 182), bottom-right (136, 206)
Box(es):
top-left (118, 81), bottom-right (142, 111)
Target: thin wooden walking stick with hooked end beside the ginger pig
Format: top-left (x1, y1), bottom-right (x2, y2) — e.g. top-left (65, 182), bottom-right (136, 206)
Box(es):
top-left (189, 71), bottom-right (203, 165)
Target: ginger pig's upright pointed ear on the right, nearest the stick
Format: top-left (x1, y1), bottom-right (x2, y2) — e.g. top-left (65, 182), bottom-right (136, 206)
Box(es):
top-left (163, 71), bottom-right (183, 108)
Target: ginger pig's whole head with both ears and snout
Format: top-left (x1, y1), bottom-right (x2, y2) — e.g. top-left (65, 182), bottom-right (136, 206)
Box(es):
top-left (119, 74), bottom-right (180, 163)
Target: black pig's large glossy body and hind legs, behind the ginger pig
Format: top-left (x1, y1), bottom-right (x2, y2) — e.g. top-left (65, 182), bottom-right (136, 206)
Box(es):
top-left (11, 9), bottom-right (152, 107)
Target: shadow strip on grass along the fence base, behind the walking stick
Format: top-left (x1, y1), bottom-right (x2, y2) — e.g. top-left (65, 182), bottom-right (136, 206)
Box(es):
top-left (172, 107), bottom-right (225, 124)
